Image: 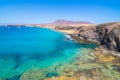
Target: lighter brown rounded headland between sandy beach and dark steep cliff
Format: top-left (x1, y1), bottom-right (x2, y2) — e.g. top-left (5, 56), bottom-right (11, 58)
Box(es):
top-left (73, 26), bottom-right (98, 42)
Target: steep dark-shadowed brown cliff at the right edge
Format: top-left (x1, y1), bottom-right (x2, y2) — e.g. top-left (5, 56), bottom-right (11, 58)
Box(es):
top-left (96, 22), bottom-right (120, 52)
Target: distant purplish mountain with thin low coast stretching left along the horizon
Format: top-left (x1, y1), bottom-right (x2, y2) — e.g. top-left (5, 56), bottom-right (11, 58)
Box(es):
top-left (0, 19), bottom-right (93, 28)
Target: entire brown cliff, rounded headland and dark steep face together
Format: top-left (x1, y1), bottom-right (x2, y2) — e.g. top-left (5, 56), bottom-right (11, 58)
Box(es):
top-left (74, 22), bottom-right (120, 52)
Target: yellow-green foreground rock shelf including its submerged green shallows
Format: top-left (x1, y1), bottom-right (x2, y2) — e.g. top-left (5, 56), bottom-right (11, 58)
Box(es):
top-left (20, 47), bottom-right (120, 80)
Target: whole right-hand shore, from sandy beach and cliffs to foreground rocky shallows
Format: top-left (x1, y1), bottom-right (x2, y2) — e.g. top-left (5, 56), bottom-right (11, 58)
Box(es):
top-left (1, 22), bottom-right (120, 80)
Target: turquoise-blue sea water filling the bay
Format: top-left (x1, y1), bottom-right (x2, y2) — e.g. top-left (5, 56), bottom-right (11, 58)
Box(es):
top-left (0, 26), bottom-right (96, 80)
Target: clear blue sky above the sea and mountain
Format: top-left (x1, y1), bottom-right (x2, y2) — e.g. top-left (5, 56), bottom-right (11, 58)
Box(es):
top-left (0, 0), bottom-right (120, 24)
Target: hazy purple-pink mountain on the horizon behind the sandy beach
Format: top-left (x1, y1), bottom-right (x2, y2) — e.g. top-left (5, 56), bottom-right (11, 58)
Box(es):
top-left (42, 19), bottom-right (92, 27)
